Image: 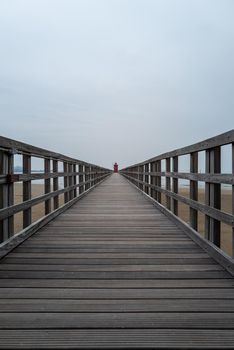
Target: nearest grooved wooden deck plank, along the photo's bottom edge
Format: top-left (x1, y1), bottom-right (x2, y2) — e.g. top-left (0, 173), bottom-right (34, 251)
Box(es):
top-left (0, 328), bottom-right (234, 349)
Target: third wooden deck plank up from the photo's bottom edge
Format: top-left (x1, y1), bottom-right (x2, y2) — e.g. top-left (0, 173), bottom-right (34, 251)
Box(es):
top-left (0, 297), bottom-right (234, 314)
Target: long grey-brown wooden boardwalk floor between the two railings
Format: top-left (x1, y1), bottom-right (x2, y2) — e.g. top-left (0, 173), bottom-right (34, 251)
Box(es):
top-left (0, 174), bottom-right (234, 349)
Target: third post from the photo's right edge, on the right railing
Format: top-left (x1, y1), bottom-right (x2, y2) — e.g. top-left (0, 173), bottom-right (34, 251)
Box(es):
top-left (189, 152), bottom-right (198, 231)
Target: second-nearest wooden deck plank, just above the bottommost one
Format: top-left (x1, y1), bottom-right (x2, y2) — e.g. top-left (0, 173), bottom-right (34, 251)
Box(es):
top-left (0, 312), bottom-right (234, 330)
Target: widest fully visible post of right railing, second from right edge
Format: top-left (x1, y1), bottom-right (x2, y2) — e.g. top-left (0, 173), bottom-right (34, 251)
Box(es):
top-left (205, 147), bottom-right (221, 247)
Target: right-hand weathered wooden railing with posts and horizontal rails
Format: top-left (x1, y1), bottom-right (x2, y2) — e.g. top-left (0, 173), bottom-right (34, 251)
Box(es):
top-left (120, 130), bottom-right (234, 270)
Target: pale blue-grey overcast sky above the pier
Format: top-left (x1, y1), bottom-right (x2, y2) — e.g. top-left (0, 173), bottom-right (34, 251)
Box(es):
top-left (0, 0), bottom-right (234, 167)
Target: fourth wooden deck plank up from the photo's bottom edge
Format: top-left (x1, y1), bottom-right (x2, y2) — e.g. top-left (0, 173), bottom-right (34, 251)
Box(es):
top-left (0, 287), bottom-right (234, 298)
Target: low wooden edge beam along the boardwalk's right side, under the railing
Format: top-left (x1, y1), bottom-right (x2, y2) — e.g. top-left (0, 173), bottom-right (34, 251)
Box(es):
top-left (122, 175), bottom-right (234, 276)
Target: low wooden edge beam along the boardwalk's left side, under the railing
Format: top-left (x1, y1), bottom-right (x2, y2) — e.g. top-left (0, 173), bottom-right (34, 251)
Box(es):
top-left (0, 174), bottom-right (111, 260)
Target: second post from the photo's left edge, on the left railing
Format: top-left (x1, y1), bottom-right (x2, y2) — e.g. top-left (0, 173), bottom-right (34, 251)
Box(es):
top-left (23, 154), bottom-right (32, 228)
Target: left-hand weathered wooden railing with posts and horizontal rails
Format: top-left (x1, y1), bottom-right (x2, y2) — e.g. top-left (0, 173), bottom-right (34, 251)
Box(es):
top-left (0, 137), bottom-right (112, 249)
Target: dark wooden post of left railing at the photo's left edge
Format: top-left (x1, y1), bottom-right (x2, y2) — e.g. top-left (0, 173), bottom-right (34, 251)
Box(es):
top-left (0, 151), bottom-right (14, 242)
